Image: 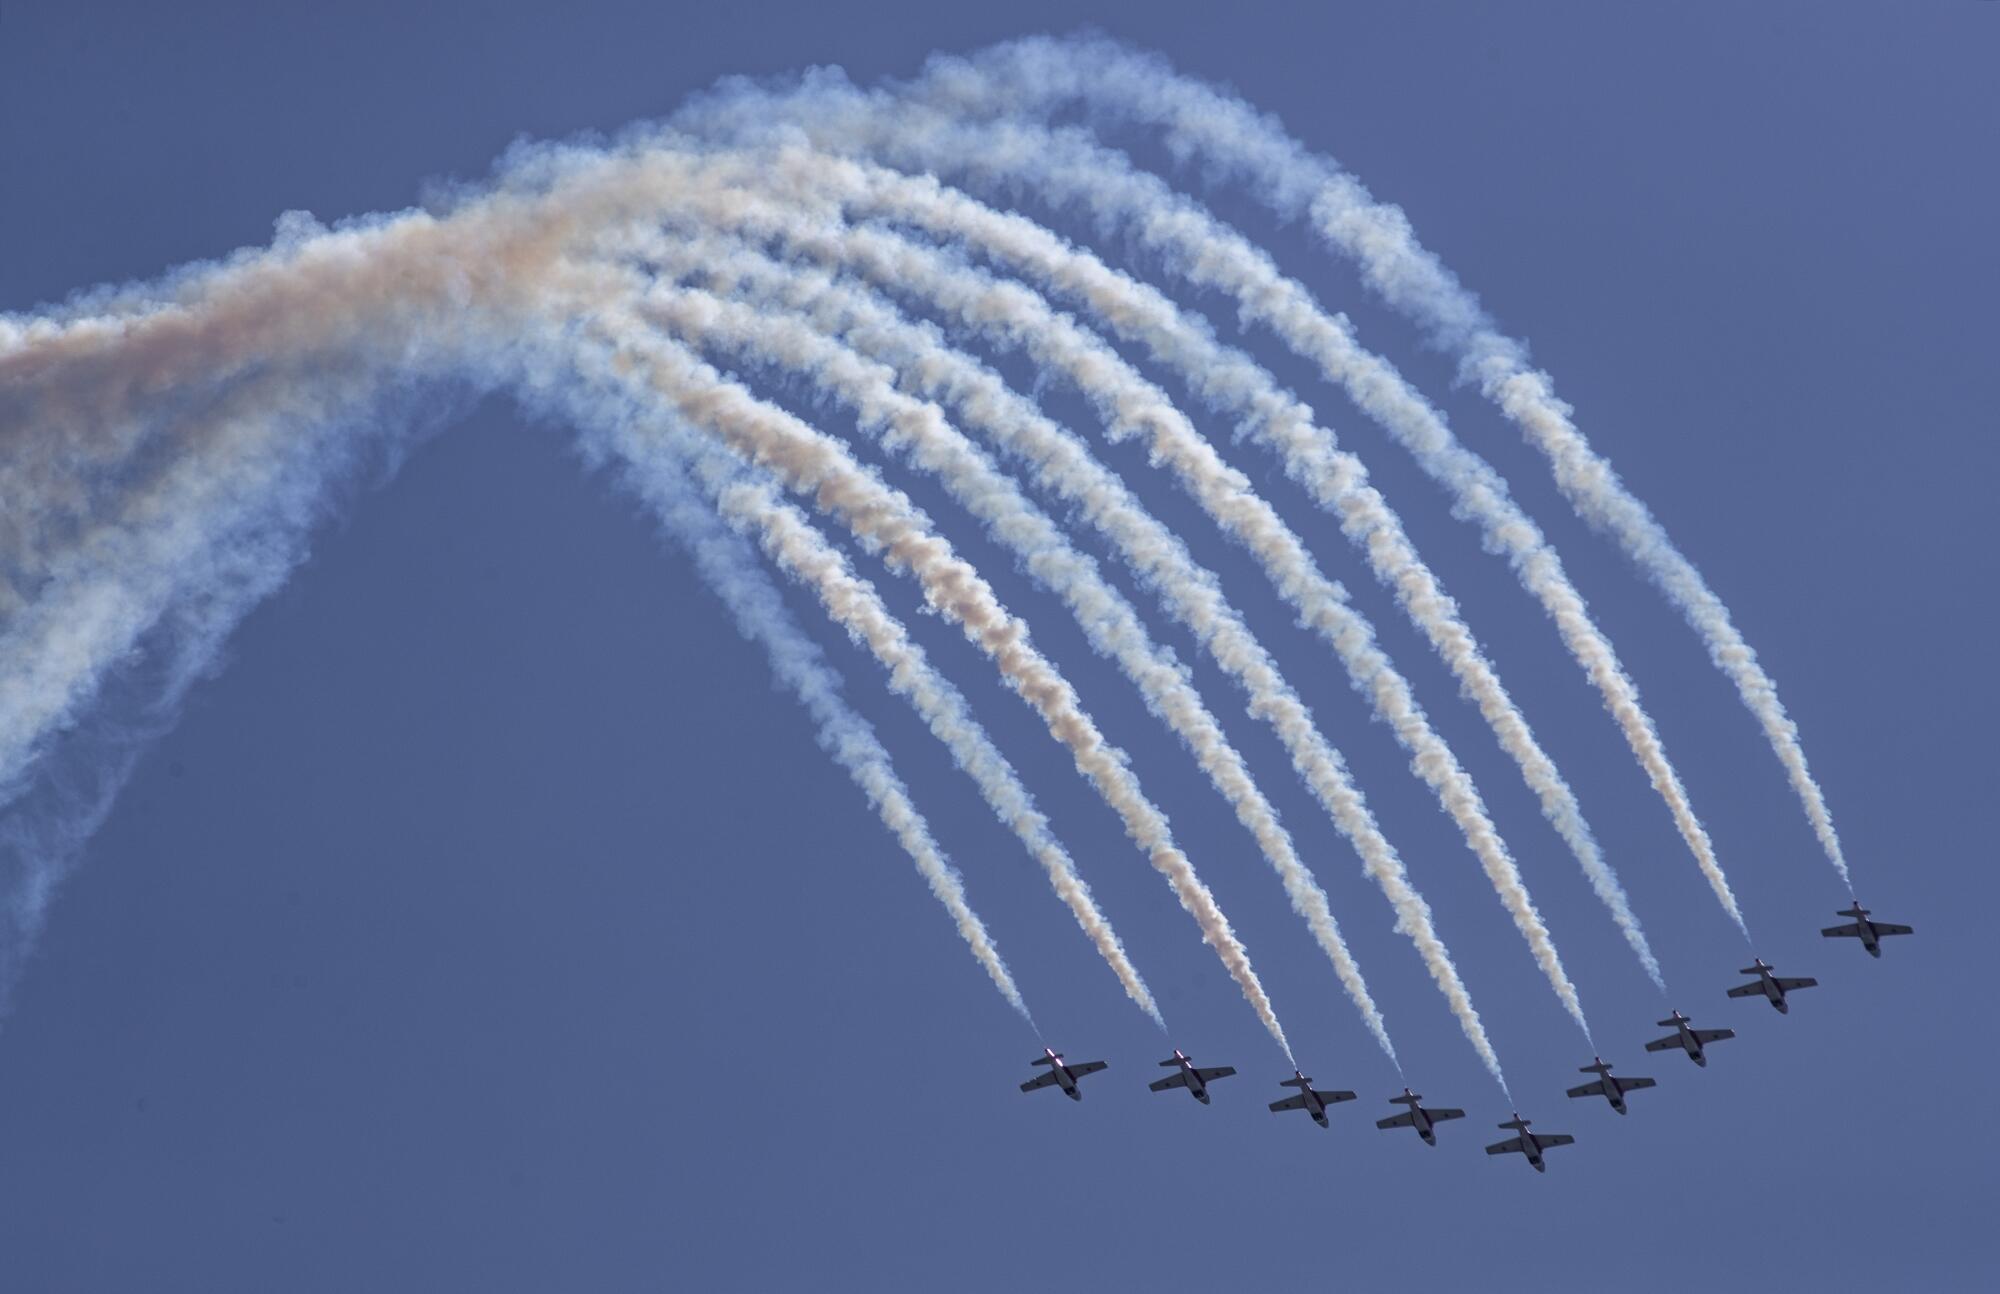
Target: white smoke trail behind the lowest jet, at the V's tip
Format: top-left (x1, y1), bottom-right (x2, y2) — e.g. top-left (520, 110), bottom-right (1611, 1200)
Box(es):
top-left (616, 225), bottom-right (1506, 1088)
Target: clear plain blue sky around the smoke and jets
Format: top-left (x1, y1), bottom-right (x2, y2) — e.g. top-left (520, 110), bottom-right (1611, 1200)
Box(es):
top-left (0, 2), bottom-right (2000, 1290)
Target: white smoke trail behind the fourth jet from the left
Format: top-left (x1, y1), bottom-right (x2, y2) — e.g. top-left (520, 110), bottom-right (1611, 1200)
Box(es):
top-left (616, 260), bottom-right (1396, 1060)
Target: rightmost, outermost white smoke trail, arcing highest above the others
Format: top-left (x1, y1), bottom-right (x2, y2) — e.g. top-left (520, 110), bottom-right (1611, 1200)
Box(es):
top-left (904, 40), bottom-right (1852, 924)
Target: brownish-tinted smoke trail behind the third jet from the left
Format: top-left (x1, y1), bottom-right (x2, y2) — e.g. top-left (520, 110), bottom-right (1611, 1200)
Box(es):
top-left (550, 294), bottom-right (1290, 1056)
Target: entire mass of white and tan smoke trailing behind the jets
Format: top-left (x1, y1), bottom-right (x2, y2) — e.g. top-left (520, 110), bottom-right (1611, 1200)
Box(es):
top-left (0, 42), bottom-right (1846, 1078)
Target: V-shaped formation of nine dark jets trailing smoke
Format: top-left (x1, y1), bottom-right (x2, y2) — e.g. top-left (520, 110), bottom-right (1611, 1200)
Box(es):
top-left (1020, 902), bottom-right (1912, 1172)
